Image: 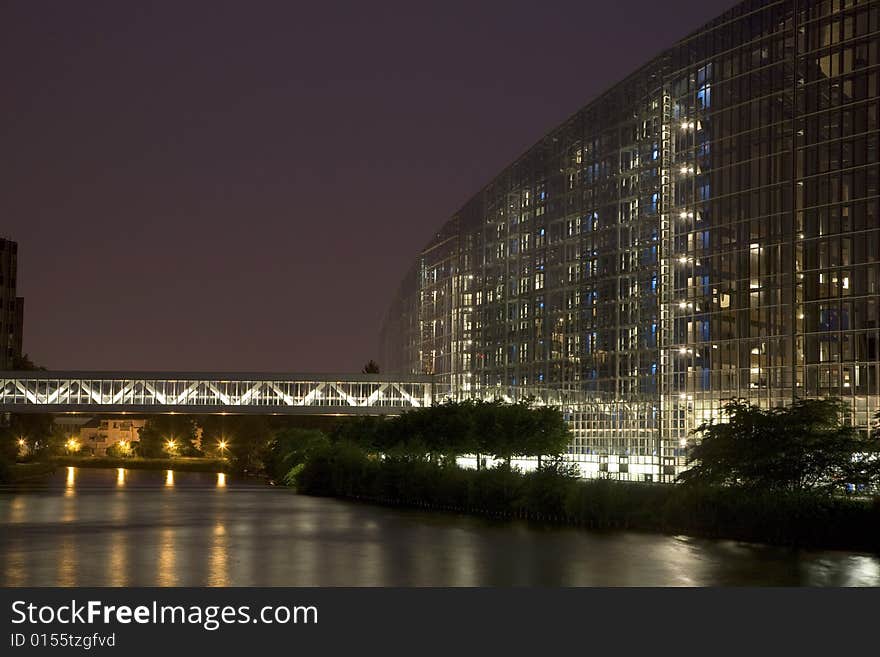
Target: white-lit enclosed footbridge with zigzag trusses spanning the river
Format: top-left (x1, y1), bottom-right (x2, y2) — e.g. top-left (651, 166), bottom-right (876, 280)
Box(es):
top-left (0, 371), bottom-right (434, 415)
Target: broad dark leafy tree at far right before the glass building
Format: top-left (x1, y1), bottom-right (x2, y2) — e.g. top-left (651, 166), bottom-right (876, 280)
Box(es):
top-left (678, 399), bottom-right (880, 493)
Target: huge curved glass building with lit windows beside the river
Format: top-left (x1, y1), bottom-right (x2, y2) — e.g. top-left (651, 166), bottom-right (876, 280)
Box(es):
top-left (381, 0), bottom-right (880, 481)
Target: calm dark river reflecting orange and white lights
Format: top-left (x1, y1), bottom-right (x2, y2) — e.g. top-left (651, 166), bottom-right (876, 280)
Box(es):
top-left (0, 468), bottom-right (880, 586)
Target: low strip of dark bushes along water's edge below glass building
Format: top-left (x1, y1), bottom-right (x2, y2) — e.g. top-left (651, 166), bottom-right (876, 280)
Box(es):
top-left (296, 444), bottom-right (880, 552)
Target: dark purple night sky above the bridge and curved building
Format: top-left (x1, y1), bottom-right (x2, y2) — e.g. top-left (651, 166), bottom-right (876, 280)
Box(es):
top-left (0, 0), bottom-right (734, 372)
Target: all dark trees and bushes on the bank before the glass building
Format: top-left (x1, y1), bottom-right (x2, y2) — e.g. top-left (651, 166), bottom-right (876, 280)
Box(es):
top-left (271, 400), bottom-right (880, 550)
